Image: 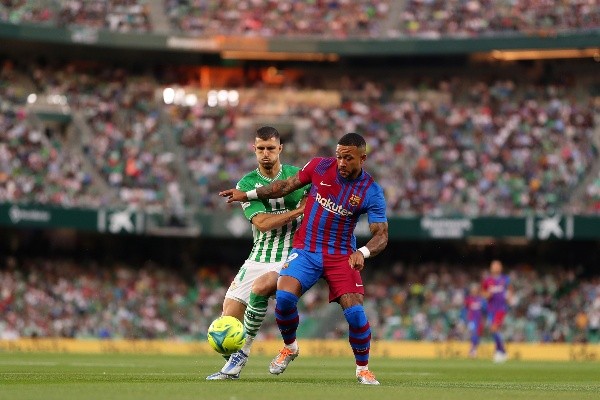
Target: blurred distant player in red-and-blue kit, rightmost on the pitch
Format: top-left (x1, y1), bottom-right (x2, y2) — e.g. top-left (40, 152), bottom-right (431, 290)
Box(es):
top-left (481, 260), bottom-right (510, 363)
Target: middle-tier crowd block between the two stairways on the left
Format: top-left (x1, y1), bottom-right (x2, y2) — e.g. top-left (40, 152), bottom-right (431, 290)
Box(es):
top-left (28, 60), bottom-right (183, 212)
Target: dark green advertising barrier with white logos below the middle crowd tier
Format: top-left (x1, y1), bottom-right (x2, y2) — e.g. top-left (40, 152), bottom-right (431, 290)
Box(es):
top-left (0, 203), bottom-right (600, 240)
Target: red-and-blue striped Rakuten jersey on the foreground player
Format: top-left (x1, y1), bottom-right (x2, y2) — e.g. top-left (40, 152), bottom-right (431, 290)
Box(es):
top-left (293, 157), bottom-right (387, 254)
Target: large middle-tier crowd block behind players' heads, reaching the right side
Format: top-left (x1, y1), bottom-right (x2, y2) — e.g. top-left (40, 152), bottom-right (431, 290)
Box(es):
top-left (162, 70), bottom-right (599, 215)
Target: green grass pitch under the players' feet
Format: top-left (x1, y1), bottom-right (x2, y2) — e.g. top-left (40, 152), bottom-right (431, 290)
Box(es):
top-left (0, 353), bottom-right (600, 400)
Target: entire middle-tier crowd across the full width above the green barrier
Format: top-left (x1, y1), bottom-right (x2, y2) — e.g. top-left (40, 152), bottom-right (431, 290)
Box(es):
top-left (2, 56), bottom-right (600, 216)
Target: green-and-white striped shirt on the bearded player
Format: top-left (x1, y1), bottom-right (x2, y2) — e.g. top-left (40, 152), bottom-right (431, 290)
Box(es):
top-left (236, 164), bottom-right (308, 262)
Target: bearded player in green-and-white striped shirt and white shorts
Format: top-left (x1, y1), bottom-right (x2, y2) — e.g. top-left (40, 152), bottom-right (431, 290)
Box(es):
top-left (206, 126), bottom-right (308, 380)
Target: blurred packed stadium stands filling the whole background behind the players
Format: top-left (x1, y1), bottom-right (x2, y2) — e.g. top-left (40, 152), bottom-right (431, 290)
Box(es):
top-left (0, 0), bottom-right (600, 342)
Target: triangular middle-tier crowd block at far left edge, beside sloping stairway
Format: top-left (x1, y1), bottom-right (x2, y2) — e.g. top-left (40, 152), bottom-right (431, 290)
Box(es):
top-left (0, 63), bottom-right (102, 207)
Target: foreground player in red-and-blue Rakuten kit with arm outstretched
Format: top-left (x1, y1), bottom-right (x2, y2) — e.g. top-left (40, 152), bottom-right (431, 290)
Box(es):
top-left (219, 133), bottom-right (388, 385)
